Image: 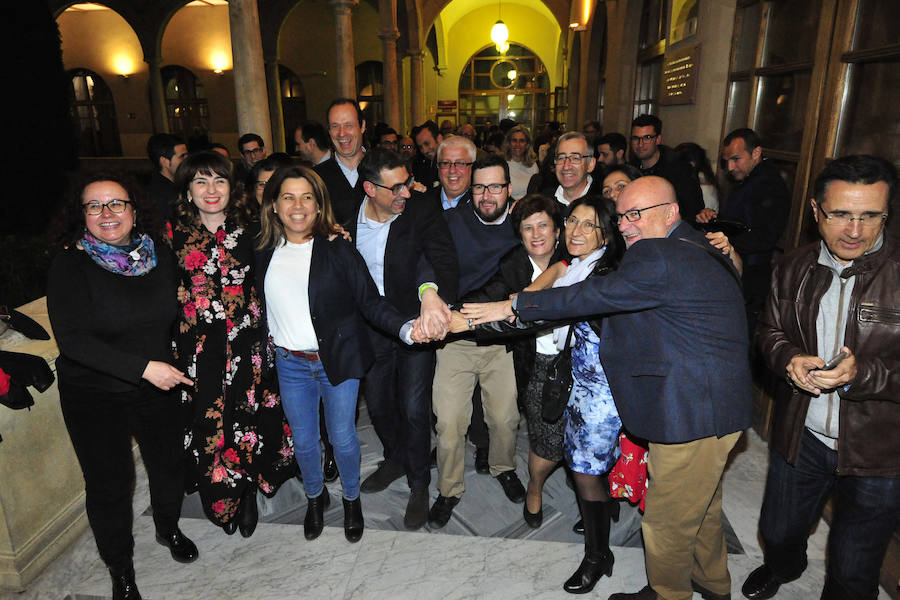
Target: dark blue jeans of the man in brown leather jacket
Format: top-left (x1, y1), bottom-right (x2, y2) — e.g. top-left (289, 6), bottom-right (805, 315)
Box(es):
top-left (759, 430), bottom-right (900, 600)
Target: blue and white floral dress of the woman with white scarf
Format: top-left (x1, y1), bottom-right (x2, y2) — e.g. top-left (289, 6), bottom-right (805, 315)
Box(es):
top-left (563, 321), bottom-right (622, 475)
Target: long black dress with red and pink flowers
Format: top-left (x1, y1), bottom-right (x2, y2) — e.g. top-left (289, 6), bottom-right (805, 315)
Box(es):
top-left (172, 221), bottom-right (296, 525)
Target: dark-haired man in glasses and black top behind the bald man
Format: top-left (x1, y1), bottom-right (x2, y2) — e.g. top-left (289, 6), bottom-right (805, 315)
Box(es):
top-left (631, 115), bottom-right (703, 223)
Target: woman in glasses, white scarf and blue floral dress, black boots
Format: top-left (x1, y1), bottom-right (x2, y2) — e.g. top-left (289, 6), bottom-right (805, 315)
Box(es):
top-left (462, 196), bottom-right (624, 594)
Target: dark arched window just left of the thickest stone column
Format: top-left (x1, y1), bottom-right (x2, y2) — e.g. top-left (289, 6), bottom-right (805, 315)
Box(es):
top-left (160, 65), bottom-right (209, 145)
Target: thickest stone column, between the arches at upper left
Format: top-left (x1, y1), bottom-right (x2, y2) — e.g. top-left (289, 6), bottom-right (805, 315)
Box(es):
top-left (228, 0), bottom-right (272, 148)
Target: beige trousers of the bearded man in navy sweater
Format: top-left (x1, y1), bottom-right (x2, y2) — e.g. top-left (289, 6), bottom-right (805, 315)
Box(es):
top-left (432, 340), bottom-right (519, 498)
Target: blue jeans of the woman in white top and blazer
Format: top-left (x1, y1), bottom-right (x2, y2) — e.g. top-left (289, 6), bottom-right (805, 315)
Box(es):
top-left (275, 348), bottom-right (360, 500)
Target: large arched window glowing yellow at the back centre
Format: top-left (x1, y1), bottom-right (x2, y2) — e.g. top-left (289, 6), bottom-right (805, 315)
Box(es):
top-left (459, 42), bottom-right (552, 131)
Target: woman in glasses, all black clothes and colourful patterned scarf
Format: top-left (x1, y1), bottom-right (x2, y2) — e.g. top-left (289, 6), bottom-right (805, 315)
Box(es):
top-left (47, 173), bottom-right (198, 600)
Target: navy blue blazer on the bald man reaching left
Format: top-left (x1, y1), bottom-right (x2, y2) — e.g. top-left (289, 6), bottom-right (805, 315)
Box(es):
top-left (516, 222), bottom-right (753, 443)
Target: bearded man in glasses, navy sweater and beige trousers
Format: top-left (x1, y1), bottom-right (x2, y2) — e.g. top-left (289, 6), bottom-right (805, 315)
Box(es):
top-left (428, 156), bottom-right (525, 528)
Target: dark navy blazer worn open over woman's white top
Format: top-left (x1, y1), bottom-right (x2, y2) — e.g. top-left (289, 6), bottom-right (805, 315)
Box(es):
top-left (256, 236), bottom-right (413, 385)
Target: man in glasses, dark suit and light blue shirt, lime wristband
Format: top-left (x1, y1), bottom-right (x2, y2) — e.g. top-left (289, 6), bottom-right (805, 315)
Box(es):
top-left (345, 148), bottom-right (459, 530)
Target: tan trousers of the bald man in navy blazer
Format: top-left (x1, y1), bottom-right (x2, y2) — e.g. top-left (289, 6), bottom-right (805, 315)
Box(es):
top-left (641, 431), bottom-right (741, 600)
